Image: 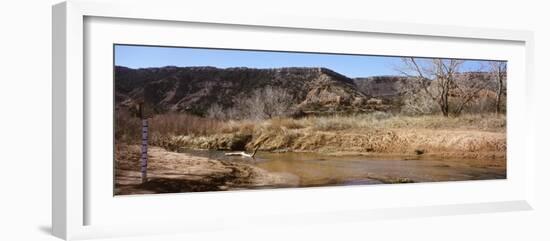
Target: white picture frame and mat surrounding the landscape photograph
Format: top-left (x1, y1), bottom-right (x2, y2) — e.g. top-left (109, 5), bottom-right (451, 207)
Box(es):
top-left (52, 0), bottom-right (536, 239)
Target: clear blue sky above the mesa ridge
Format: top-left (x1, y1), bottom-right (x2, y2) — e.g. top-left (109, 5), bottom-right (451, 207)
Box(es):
top-left (115, 45), bottom-right (498, 78)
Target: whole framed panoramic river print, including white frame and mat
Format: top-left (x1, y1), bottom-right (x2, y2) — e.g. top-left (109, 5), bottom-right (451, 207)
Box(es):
top-left (53, 0), bottom-right (535, 239)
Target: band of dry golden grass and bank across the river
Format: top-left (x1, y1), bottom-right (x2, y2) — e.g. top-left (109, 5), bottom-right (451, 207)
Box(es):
top-left (117, 112), bottom-right (506, 157)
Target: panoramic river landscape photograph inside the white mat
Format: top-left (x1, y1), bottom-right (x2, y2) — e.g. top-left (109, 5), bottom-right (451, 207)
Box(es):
top-left (113, 44), bottom-right (507, 196)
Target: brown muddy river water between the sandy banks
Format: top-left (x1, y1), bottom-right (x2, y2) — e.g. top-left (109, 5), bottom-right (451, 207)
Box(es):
top-left (184, 150), bottom-right (506, 187)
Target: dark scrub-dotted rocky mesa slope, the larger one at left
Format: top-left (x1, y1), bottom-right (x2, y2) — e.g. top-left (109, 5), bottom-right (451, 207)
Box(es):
top-left (115, 66), bottom-right (374, 115)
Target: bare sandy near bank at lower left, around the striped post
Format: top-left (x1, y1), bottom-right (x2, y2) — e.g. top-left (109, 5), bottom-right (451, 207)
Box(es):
top-left (115, 145), bottom-right (298, 195)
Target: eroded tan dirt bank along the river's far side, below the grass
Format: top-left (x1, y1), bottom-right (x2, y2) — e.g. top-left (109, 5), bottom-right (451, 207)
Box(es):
top-left (155, 128), bottom-right (506, 159)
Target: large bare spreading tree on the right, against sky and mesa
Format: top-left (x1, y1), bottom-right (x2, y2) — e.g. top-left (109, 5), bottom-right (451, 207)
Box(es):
top-left (401, 57), bottom-right (488, 117)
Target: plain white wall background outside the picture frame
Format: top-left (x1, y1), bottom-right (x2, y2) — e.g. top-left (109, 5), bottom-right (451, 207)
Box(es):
top-left (0, 0), bottom-right (550, 241)
